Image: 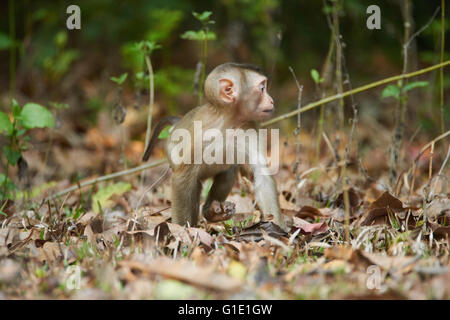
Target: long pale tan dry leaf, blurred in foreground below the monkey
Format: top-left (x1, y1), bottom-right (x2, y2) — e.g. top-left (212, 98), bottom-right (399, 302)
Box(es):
top-left (119, 257), bottom-right (242, 291)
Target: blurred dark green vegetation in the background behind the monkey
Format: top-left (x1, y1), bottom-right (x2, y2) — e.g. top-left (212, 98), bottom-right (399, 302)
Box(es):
top-left (0, 0), bottom-right (450, 182)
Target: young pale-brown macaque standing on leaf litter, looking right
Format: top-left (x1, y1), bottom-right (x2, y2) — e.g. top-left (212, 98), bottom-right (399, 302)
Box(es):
top-left (143, 63), bottom-right (285, 228)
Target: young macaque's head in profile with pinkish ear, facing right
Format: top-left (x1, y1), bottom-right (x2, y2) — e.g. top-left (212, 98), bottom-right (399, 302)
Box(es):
top-left (205, 63), bottom-right (275, 121)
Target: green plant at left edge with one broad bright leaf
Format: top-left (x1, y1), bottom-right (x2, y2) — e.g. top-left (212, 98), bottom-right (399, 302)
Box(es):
top-left (0, 99), bottom-right (55, 202)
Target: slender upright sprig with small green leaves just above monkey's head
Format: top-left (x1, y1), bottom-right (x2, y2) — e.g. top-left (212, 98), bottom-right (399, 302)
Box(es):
top-left (181, 11), bottom-right (216, 104)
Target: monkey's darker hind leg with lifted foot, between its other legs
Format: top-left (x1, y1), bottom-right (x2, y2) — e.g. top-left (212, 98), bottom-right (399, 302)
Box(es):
top-left (202, 166), bottom-right (237, 222)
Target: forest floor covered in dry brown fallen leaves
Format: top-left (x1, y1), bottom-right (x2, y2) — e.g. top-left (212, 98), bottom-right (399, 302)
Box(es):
top-left (0, 103), bottom-right (450, 299)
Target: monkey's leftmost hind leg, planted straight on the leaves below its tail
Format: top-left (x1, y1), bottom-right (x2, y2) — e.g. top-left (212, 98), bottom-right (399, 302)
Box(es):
top-left (171, 168), bottom-right (202, 226)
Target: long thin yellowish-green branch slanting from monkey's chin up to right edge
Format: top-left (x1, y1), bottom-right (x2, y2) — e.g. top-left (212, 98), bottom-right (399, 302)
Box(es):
top-left (261, 60), bottom-right (450, 127)
